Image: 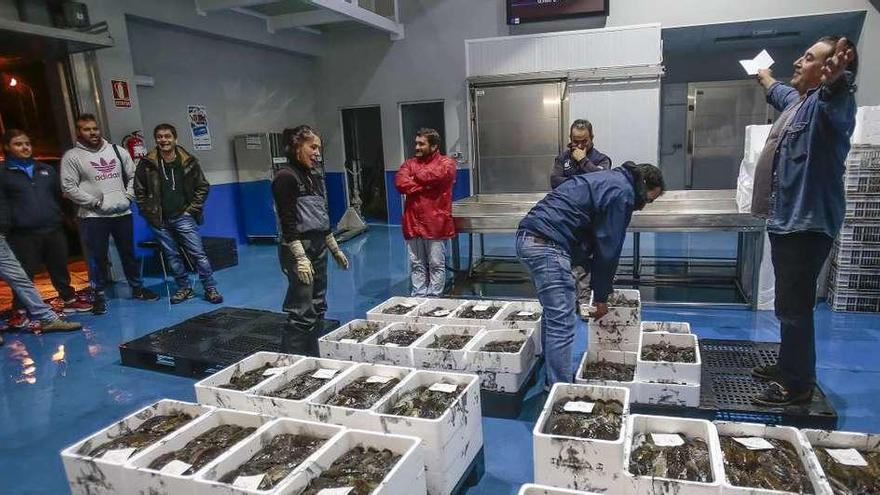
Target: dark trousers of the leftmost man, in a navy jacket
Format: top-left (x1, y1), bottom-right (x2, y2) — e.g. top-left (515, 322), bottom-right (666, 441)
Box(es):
top-left (6, 227), bottom-right (76, 309)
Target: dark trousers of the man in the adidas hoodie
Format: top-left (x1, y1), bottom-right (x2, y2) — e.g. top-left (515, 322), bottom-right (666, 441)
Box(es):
top-left (79, 214), bottom-right (144, 293)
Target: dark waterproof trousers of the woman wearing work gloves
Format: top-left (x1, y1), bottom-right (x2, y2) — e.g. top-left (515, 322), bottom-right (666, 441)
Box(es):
top-left (278, 235), bottom-right (327, 355)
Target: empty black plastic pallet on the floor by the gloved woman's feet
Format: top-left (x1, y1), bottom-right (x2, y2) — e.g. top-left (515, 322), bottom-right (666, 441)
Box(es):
top-left (119, 307), bottom-right (339, 378)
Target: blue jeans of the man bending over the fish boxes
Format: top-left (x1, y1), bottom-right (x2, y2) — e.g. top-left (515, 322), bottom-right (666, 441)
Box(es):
top-left (516, 230), bottom-right (577, 387)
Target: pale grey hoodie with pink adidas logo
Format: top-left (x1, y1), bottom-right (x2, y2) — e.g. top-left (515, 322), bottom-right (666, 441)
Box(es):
top-left (61, 139), bottom-right (135, 218)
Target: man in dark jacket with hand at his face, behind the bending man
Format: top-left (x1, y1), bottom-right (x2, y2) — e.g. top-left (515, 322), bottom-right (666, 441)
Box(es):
top-left (550, 119), bottom-right (611, 315)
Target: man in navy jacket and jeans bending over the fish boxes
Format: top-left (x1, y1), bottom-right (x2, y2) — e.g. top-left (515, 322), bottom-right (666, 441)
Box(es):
top-left (516, 162), bottom-right (666, 389)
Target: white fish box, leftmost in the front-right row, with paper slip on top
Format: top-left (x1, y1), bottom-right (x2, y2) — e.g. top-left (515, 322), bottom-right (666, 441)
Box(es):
top-left (533, 383), bottom-right (630, 493)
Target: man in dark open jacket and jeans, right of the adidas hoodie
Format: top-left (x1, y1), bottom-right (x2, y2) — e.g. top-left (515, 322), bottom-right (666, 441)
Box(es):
top-left (134, 124), bottom-right (223, 304)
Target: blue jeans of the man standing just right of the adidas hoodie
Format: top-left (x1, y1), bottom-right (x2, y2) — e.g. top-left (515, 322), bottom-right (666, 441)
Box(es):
top-left (153, 213), bottom-right (217, 289)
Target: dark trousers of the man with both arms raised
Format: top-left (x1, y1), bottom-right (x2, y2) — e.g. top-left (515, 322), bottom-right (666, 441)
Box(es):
top-left (770, 232), bottom-right (834, 392)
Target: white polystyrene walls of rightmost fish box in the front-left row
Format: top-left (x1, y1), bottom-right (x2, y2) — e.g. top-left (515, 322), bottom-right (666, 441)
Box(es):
top-left (276, 430), bottom-right (427, 495)
